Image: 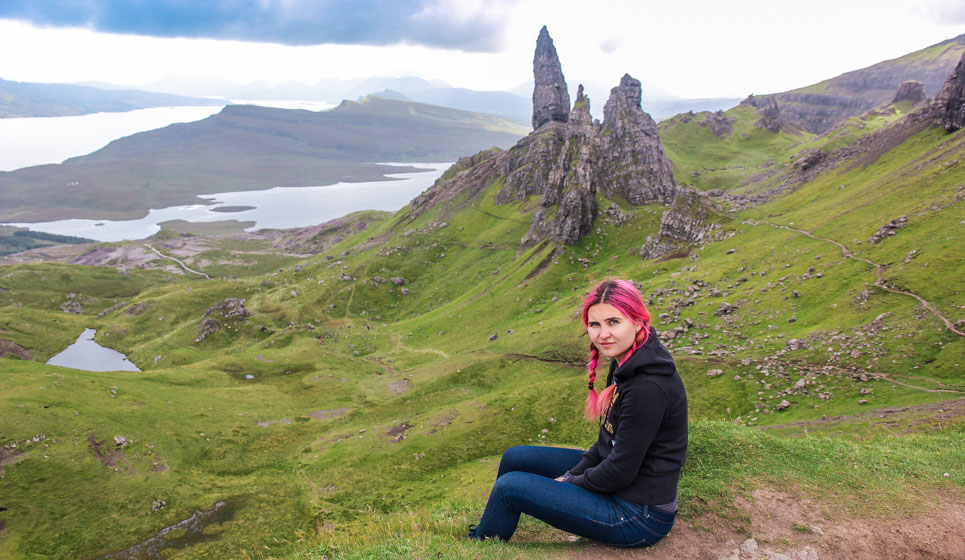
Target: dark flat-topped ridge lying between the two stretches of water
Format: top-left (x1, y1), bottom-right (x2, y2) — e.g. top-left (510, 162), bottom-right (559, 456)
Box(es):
top-left (0, 97), bottom-right (529, 222)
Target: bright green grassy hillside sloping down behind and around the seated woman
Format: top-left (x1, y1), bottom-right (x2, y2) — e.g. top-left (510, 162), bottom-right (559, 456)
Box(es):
top-left (0, 103), bottom-right (965, 559)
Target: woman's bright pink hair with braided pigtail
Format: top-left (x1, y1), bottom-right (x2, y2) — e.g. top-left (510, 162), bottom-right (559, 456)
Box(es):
top-left (583, 280), bottom-right (650, 420)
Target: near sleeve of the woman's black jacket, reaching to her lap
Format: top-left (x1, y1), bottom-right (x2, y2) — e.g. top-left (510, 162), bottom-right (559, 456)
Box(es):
top-left (568, 382), bottom-right (668, 494)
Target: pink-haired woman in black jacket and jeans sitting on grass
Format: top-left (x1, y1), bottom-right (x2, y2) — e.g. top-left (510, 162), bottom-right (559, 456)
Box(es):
top-left (469, 280), bottom-right (687, 547)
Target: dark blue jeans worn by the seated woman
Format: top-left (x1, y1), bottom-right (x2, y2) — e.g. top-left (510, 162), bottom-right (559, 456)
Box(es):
top-left (472, 445), bottom-right (676, 547)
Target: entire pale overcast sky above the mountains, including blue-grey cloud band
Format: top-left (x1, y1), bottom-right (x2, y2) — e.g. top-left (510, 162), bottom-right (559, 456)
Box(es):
top-left (0, 0), bottom-right (965, 104)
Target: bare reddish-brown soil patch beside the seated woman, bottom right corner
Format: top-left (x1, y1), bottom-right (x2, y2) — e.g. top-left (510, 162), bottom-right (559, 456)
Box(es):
top-left (536, 488), bottom-right (965, 560)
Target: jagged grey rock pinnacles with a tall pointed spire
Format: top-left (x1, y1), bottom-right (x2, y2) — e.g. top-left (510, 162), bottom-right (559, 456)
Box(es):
top-left (409, 27), bottom-right (711, 254)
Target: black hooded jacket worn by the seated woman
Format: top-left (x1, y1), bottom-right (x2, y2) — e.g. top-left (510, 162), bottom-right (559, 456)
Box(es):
top-left (564, 327), bottom-right (687, 506)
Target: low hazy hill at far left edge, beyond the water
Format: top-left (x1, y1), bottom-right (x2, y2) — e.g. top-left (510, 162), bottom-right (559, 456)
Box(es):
top-left (0, 79), bottom-right (224, 118)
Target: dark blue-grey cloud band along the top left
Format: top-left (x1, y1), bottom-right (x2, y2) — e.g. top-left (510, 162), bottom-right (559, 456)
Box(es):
top-left (0, 0), bottom-right (507, 51)
